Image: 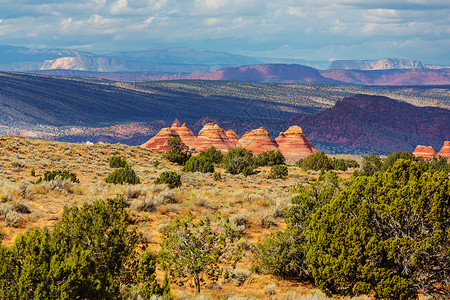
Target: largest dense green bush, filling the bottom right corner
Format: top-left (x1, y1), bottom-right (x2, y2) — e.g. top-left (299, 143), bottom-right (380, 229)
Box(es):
top-left (307, 159), bottom-right (450, 299)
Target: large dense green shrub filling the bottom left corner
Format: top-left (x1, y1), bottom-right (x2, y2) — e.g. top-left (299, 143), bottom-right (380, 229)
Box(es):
top-left (0, 197), bottom-right (168, 299)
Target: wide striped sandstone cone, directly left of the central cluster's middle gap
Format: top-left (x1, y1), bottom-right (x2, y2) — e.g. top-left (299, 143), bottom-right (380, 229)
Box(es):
top-left (192, 123), bottom-right (235, 152)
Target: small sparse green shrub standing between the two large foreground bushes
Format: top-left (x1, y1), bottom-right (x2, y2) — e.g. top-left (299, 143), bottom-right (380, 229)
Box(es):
top-left (159, 213), bottom-right (241, 293)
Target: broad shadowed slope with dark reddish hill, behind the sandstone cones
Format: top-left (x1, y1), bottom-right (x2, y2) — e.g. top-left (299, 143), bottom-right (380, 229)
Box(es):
top-left (0, 69), bottom-right (450, 154)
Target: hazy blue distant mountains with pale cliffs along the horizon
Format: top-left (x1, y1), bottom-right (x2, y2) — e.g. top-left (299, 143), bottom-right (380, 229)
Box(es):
top-left (0, 46), bottom-right (450, 85)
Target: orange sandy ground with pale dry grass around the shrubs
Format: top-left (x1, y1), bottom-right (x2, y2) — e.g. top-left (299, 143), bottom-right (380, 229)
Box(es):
top-left (0, 136), bottom-right (362, 299)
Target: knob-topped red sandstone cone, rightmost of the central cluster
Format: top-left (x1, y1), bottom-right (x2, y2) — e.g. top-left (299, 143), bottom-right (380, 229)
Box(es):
top-left (275, 126), bottom-right (317, 158)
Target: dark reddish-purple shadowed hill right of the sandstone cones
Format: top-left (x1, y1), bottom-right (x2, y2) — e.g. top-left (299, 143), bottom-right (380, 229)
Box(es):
top-left (292, 95), bottom-right (450, 154)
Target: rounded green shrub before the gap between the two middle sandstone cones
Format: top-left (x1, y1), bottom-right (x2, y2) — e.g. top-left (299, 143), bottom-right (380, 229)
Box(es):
top-left (222, 148), bottom-right (255, 174)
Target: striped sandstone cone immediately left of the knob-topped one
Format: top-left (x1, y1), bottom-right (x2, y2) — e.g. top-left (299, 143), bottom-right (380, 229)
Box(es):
top-left (237, 127), bottom-right (278, 154)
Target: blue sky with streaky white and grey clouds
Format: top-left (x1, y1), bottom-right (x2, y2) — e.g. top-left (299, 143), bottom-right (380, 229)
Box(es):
top-left (0, 0), bottom-right (450, 65)
